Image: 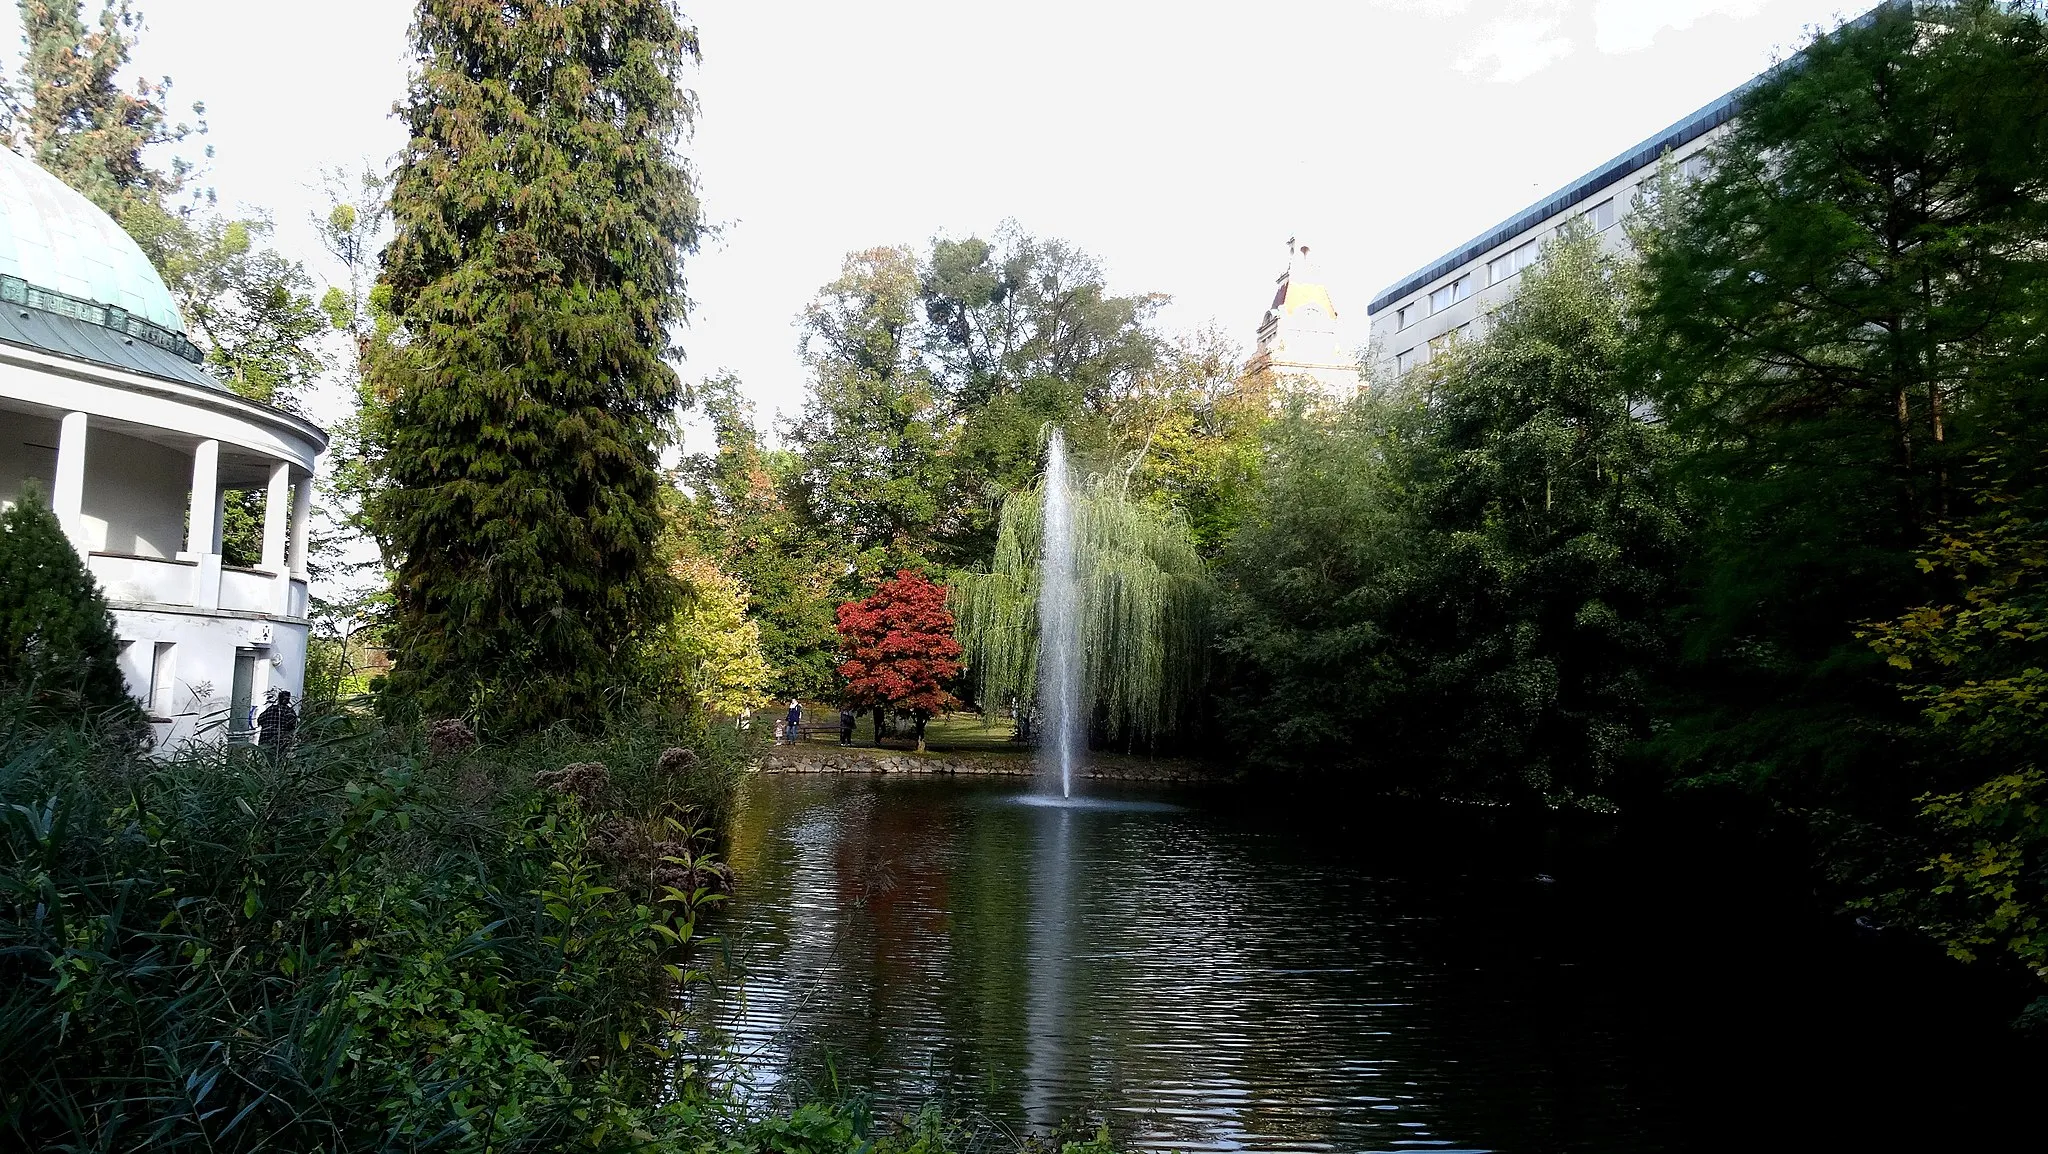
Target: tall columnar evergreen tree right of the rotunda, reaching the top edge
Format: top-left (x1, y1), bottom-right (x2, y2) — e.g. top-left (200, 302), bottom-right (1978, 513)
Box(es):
top-left (373, 0), bottom-right (700, 728)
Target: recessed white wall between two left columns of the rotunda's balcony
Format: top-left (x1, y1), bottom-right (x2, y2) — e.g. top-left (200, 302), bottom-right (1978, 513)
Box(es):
top-left (82, 426), bottom-right (193, 558)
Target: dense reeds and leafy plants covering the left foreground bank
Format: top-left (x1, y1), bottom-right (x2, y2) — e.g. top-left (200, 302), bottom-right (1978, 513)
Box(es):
top-left (0, 705), bottom-right (1105, 1152)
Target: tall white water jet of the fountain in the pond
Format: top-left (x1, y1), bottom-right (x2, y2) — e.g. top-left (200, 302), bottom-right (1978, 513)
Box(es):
top-left (1038, 430), bottom-right (1087, 797)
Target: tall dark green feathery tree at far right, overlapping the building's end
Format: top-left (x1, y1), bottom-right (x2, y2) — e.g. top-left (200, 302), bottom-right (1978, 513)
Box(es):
top-left (1638, 0), bottom-right (2048, 819)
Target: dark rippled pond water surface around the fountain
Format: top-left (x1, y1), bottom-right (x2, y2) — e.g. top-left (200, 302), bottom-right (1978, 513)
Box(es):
top-left (711, 775), bottom-right (2044, 1152)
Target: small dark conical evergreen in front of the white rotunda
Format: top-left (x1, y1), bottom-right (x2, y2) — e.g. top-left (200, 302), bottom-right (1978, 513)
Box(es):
top-left (0, 486), bottom-right (133, 711)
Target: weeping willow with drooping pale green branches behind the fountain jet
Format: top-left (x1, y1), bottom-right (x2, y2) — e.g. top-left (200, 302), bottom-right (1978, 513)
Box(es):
top-left (952, 476), bottom-right (1212, 740)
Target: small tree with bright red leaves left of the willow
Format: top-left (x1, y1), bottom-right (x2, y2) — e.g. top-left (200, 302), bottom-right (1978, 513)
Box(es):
top-left (840, 570), bottom-right (961, 752)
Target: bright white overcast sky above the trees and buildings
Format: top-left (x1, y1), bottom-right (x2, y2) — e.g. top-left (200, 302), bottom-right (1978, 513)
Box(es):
top-left (0, 0), bottom-right (1874, 434)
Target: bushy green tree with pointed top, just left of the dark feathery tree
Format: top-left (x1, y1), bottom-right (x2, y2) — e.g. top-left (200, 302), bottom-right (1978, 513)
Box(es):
top-left (1391, 232), bottom-right (1690, 808)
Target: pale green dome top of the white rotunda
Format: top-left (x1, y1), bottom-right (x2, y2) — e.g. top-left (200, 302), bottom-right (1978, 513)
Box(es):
top-left (0, 148), bottom-right (184, 332)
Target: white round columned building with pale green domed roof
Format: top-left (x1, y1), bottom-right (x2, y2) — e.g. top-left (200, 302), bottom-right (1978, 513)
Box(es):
top-left (0, 148), bottom-right (328, 748)
